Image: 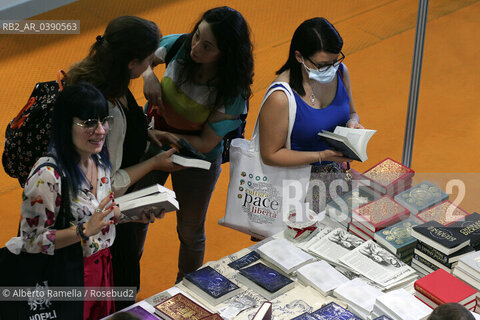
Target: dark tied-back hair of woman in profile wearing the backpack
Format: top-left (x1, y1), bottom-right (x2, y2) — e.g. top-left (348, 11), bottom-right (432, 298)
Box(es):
top-left (67, 16), bottom-right (160, 98)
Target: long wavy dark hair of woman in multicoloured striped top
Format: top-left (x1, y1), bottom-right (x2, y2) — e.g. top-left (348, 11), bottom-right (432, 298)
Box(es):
top-left (180, 7), bottom-right (253, 110)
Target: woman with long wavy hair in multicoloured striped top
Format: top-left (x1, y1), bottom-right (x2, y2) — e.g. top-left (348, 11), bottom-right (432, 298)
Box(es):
top-left (139, 7), bottom-right (253, 281)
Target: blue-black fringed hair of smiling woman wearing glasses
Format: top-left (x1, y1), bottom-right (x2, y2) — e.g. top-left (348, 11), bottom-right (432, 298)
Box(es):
top-left (50, 82), bottom-right (111, 197)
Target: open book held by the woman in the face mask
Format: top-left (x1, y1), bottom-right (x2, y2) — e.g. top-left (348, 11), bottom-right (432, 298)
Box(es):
top-left (318, 126), bottom-right (377, 162)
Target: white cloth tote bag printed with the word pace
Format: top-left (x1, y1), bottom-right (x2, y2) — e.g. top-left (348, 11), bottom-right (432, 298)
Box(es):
top-left (218, 82), bottom-right (311, 239)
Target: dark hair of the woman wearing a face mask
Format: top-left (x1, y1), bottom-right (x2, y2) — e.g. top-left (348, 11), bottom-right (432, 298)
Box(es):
top-left (276, 18), bottom-right (343, 96)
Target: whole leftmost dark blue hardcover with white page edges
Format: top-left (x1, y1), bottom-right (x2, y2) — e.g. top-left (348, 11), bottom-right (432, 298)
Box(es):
top-left (183, 266), bottom-right (241, 306)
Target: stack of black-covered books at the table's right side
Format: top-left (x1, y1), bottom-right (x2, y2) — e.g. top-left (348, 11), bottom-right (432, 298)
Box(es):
top-left (412, 220), bottom-right (473, 275)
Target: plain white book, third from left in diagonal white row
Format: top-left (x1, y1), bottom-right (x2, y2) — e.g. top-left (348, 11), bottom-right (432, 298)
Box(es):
top-left (333, 278), bottom-right (383, 319)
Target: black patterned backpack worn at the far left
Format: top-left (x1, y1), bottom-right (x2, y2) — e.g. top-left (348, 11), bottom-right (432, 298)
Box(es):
top-left (2, 76), bottom-right (61, 188)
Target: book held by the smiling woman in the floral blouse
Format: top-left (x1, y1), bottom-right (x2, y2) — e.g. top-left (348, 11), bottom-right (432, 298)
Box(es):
top-left (115, 192), bottom-right (179, 220)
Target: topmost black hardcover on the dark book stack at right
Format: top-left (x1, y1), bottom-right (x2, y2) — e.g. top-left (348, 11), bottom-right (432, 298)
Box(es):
top-left (412, 220), bottom-right (470, 255)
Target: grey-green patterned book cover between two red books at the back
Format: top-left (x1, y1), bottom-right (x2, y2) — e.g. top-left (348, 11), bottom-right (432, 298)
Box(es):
top-left (394, 181), bottom-right (448, 214)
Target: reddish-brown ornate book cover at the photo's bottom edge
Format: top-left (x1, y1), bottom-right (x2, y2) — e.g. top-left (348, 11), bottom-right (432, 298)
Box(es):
top-left (155, 293), bottom-right (211, 320)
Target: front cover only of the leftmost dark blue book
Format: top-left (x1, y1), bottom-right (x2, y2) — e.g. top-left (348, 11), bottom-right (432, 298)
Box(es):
top-left (185, 266), bottom-right (239, 299)
